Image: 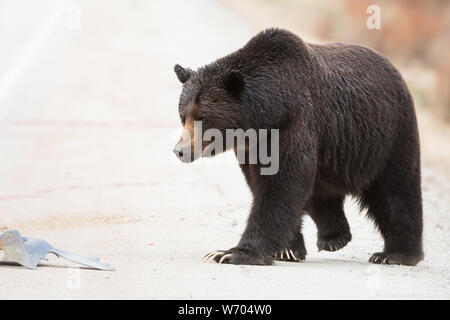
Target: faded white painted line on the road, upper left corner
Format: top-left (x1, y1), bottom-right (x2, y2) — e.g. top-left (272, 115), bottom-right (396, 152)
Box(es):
top-left (0, 0), bottom-right (68, 103)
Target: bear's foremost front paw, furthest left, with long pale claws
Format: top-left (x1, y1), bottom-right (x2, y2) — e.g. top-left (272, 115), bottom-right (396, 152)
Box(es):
top-left (203, 248), bottom-right (272, 265)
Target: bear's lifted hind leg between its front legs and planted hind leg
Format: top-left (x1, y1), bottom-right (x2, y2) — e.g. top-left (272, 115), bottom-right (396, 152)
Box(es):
top-left (308, 196), bottom-right (352, 251)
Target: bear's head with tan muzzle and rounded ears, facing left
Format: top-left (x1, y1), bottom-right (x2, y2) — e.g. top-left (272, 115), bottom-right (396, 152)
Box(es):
top-left (174, 64), bottom-right (245, 162)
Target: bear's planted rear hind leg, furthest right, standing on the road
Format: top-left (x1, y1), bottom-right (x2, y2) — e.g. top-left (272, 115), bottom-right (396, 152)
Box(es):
top-left (362, 162), bottom-right (423, 266)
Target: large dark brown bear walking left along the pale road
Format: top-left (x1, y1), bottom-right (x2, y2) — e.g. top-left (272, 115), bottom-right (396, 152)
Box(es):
top-left (174, 29), bottom-right (423, 265)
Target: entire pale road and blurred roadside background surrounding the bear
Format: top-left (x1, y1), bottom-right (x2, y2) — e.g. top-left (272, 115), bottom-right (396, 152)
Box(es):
top-left (0, 0), bottom-right (450, 299)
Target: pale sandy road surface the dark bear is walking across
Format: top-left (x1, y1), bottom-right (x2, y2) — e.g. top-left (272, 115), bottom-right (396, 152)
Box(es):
top-left (0, 0), bottom-right (450, 299)
